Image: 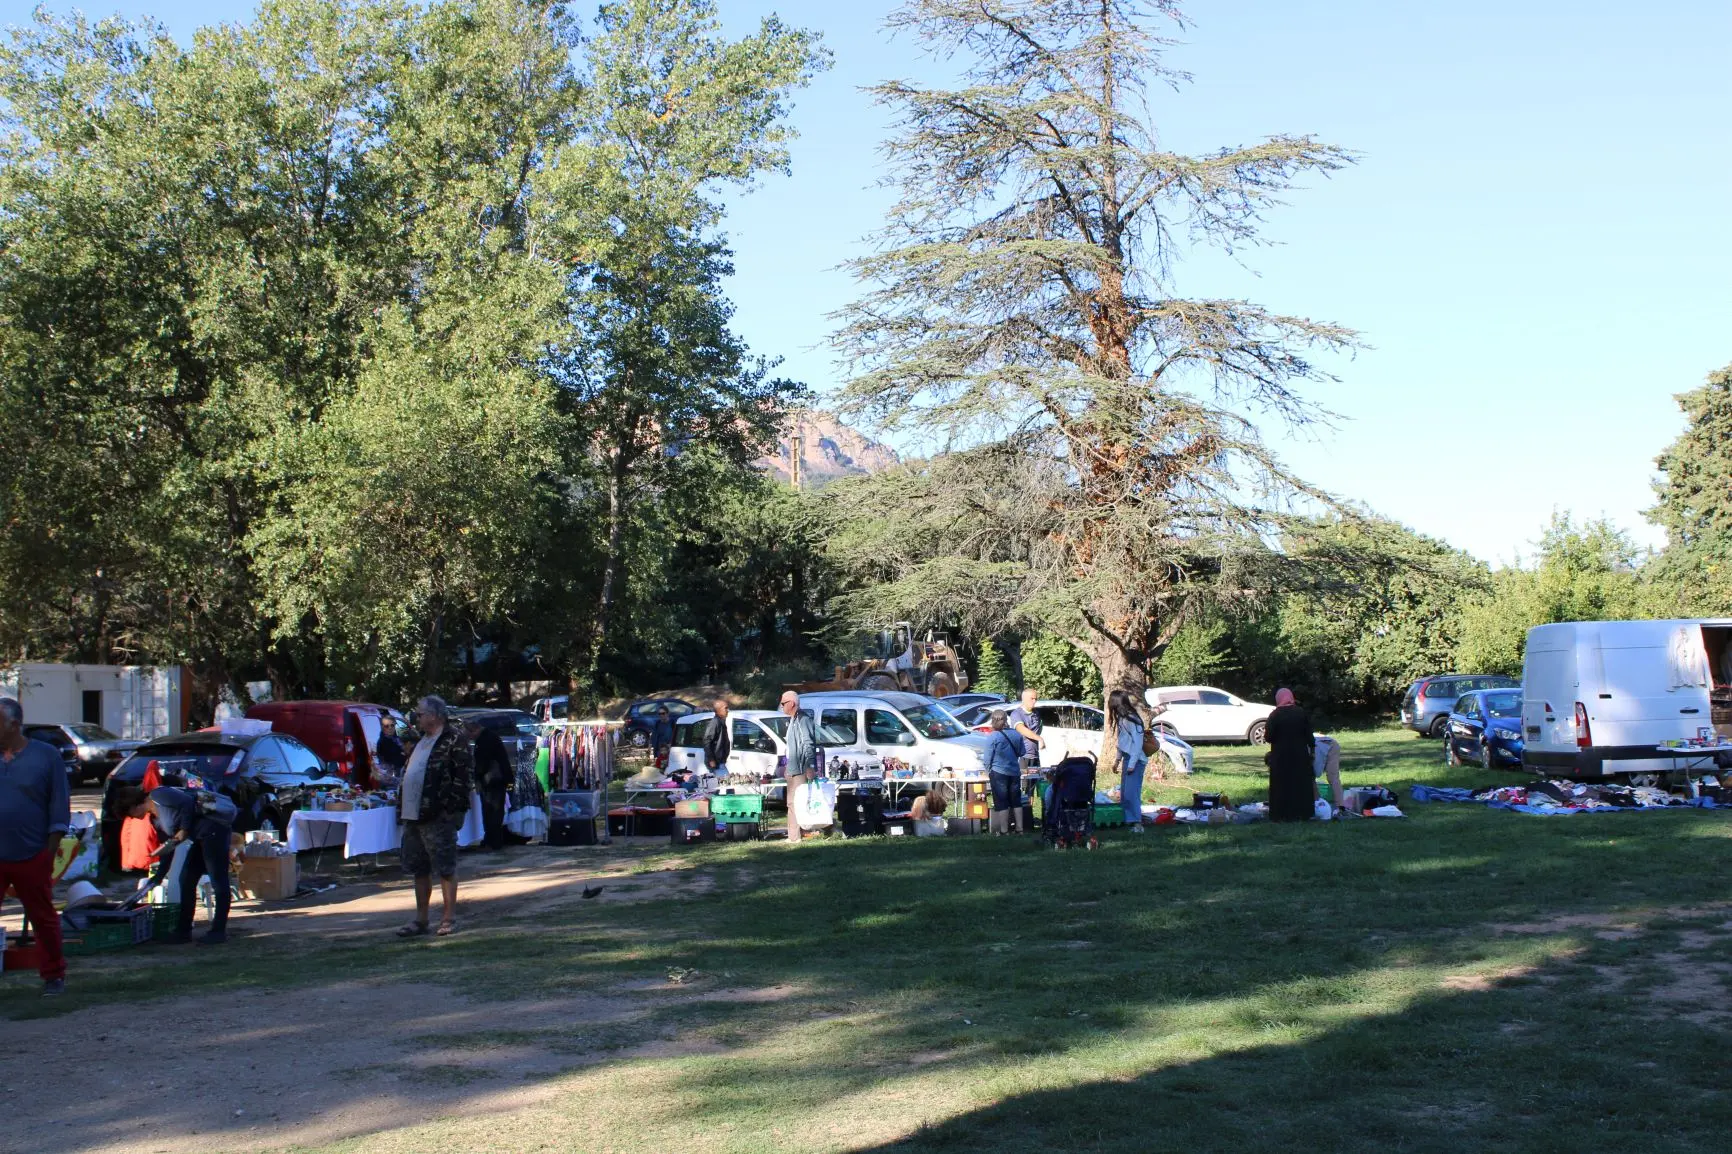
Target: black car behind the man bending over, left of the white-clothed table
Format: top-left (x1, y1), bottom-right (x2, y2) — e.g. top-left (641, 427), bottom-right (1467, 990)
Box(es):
top-left (102, 729), bottom-right (348, 870)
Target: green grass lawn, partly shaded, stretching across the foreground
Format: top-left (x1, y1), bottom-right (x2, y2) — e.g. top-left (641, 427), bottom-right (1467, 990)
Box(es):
top-left (0, 729), bottom-right (1732, 1154)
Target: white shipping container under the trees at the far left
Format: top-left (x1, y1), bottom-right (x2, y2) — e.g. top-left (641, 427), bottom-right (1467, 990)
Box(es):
top-left (0, 662), bottom-right (182, 742)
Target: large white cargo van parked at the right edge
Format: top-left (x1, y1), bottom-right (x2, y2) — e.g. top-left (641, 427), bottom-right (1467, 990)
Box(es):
top-left (1521, 619), bottom-right (1732, 778)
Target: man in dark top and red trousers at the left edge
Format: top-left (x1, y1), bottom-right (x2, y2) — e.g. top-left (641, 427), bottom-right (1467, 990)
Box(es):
top-left (0, 697), bottom-right (73, 998)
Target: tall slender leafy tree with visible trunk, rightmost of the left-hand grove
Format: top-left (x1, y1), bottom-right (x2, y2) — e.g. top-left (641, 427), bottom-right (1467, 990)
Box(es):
top-left (556, 0), bottom-right (826, 681)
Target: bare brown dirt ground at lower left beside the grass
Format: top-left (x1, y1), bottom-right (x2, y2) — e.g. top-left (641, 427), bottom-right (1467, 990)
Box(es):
top-left (0, 847), bottom-right (751, 1154)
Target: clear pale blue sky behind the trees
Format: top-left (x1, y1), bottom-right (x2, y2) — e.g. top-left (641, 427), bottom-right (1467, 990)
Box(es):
top-left (23, 0), bottom-right (1732, 561)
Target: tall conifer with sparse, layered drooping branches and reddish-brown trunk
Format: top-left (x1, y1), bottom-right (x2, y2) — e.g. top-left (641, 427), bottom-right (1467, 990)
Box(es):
top-left (838, 0), bottom-right (1353, 700)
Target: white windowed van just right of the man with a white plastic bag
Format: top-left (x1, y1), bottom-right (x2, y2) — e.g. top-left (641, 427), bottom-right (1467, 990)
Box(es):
top-left (800, 690), bottom-right (987, 769)
